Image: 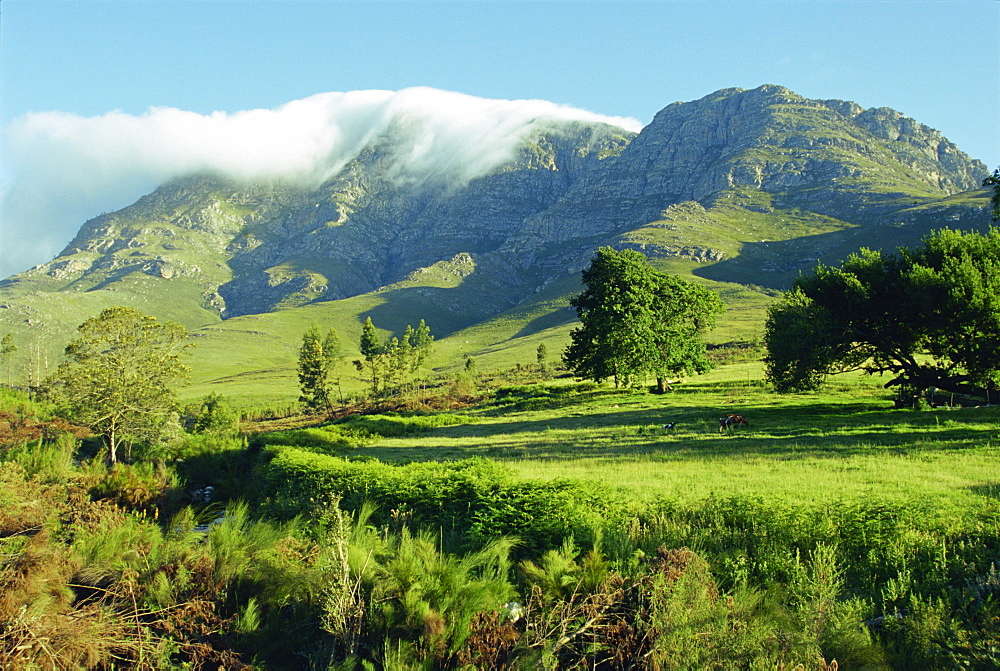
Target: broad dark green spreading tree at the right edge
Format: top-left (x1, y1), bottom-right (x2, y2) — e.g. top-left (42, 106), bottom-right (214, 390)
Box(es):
top-left (764, 228), bottom-right (1000, 398)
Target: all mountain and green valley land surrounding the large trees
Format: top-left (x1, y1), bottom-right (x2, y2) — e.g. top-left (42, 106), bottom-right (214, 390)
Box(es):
top-left (0, 86), bottom-right (1000, 671)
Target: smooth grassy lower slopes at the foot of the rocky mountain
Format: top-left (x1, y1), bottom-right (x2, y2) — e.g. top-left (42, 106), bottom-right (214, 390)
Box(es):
top-left (0, 189), bottom-right (986, 404)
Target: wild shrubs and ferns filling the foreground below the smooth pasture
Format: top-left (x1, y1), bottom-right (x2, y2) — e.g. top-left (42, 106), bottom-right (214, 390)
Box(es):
top-left (0, 385), bottom-right (1000, 669)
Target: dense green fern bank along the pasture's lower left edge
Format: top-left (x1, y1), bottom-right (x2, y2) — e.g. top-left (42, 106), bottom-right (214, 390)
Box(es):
top-left (257, 447), bottom-right (628, 551)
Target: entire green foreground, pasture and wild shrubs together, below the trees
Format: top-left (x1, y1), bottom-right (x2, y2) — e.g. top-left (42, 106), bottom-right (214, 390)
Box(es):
top-left (0, 342), bottom-right (1000, 671)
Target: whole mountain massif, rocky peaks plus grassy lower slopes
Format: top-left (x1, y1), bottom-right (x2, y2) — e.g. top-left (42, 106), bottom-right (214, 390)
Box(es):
top-left (0, 86), bottom-right (989, 400)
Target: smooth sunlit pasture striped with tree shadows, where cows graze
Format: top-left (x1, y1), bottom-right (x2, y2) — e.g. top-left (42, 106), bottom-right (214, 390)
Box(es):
top-left (356, 362), bottom-right (1000, 509)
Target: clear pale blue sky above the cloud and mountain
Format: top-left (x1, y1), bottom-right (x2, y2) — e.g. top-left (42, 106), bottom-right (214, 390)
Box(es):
top-left (0, 0), bottom-right (1000, 274)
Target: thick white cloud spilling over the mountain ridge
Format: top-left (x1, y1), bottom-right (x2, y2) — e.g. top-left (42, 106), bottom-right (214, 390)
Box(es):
top-left (0, 88), bottom-right (641, 277)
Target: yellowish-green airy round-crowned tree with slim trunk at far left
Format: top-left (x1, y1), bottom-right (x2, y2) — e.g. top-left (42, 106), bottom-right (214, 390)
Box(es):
top-left (46, 307), bottom-right (190, 463)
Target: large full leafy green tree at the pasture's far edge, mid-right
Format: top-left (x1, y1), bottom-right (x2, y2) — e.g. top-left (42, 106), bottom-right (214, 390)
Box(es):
top-left (563, 247), bottom-right (724, 390)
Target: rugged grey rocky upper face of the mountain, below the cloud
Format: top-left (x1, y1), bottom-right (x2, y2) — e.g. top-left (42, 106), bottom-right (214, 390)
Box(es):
top-left (0, 86), bottom-right (987, 326)
